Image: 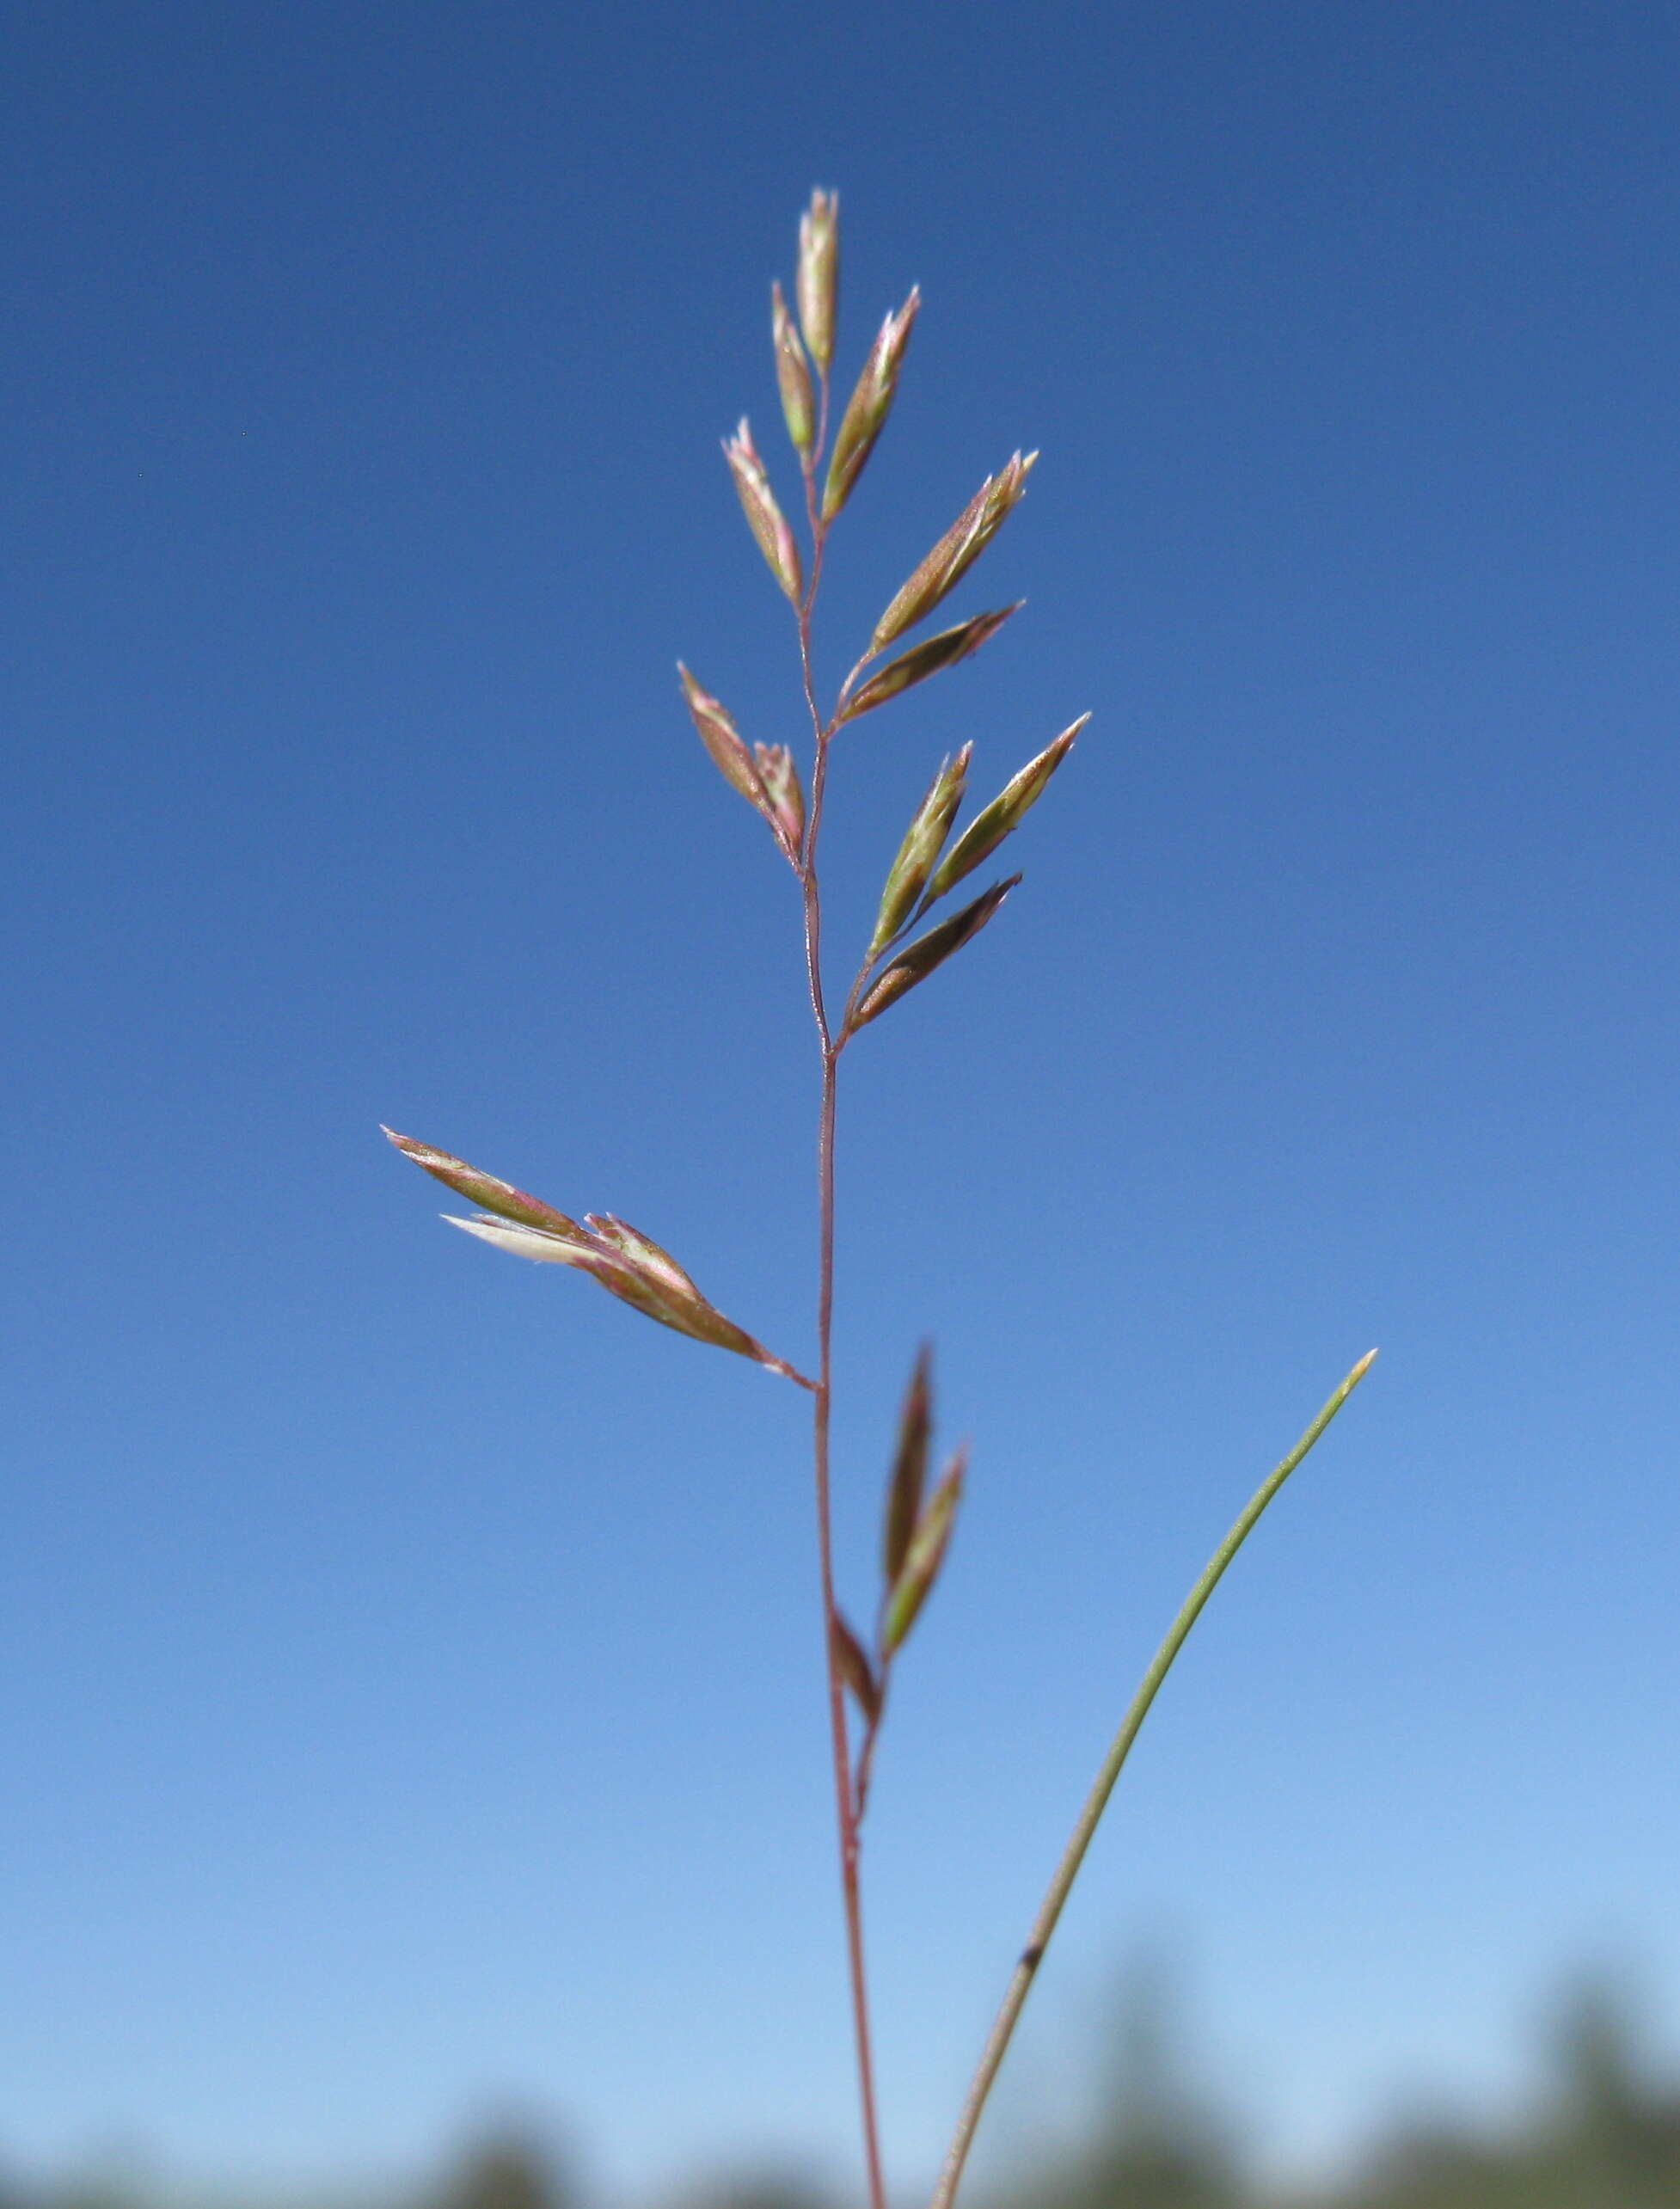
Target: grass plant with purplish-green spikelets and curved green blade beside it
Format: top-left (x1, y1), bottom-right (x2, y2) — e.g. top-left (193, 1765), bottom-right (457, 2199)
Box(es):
top-left (386, 193), bottom-right (1376, 2209)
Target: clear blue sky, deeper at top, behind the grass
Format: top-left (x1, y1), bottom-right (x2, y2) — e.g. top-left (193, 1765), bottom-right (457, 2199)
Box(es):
top-left (0, 0), bottom-right (1680, 2189)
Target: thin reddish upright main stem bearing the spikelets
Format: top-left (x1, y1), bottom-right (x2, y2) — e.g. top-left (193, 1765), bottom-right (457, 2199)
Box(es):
top-left (797, 393), bottom-right (887, 2209)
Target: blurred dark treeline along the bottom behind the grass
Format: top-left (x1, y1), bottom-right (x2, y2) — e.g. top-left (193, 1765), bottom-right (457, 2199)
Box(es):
top-left (0, 1975), bottom-right (1680, 2209)
